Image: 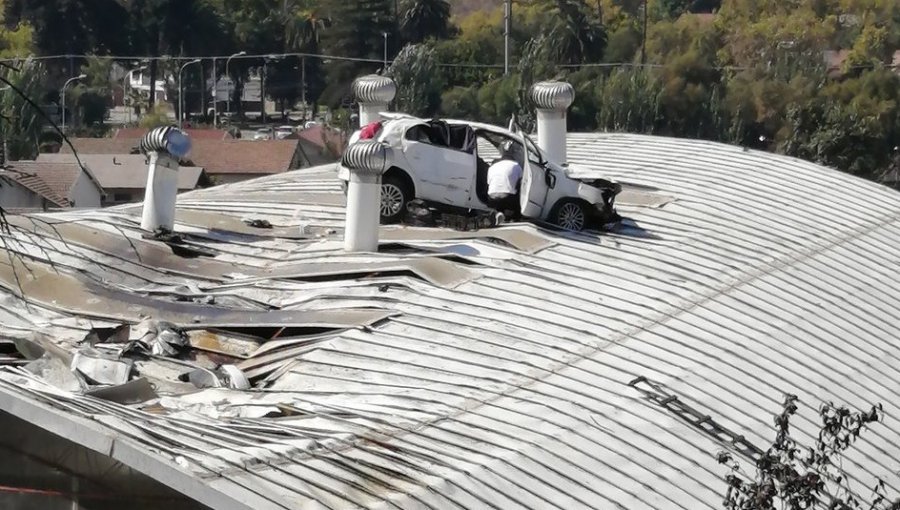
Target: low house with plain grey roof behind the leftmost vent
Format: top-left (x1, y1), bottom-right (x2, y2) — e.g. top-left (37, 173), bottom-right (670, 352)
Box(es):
top-left (37, 154), bottom-right (210, 207)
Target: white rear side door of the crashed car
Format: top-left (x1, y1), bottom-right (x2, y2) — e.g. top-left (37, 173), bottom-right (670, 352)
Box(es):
top-left (403, 125), bottom-right (475, 207)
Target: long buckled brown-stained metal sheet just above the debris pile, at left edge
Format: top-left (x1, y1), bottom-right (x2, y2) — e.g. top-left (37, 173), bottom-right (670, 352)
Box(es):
top-left (0, 258), bottom-right (395, 328)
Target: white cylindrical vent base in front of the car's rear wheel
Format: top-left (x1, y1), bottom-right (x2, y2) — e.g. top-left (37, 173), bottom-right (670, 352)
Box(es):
top-left (344, 173), bottom-right (381, 252)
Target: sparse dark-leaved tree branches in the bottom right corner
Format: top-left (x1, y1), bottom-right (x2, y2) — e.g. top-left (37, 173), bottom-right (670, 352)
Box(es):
top-left (718, 395), bottom-right (900, 510)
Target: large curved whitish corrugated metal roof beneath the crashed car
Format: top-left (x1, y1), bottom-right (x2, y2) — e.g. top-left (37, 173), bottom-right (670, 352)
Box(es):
top-left (0, 134), bottom-right (900, 509)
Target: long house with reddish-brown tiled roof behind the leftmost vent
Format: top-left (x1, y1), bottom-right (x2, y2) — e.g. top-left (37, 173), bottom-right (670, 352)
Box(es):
top-left (62, 137), bottom-right (308, 184)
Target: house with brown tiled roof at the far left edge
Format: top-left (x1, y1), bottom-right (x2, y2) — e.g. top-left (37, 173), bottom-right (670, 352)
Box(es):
top-left (0, 158), bottom-right (104, 208)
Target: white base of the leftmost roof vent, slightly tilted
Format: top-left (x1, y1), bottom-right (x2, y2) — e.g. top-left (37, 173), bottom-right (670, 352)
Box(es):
top-left (141, 151), bottom-right (178, 232)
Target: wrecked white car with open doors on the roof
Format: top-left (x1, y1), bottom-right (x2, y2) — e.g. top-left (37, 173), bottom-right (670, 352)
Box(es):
top-left (338, 113), bottom-right (621, 231)
